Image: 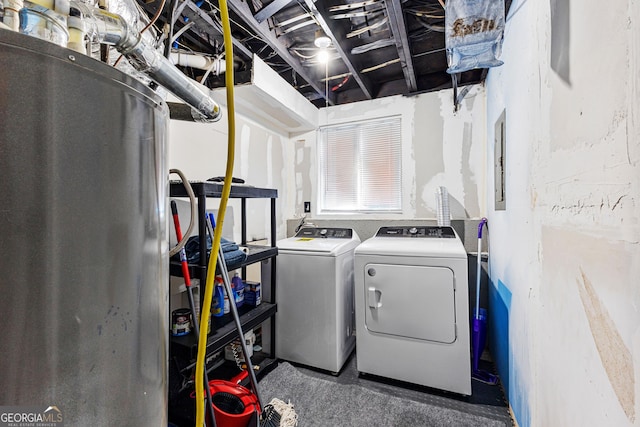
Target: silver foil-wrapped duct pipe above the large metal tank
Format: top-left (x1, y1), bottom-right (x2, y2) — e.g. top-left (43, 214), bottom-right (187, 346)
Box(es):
top-left (71, 1), bottom-right (222, 123)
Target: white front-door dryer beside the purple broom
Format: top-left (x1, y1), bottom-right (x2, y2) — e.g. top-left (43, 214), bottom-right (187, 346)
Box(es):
top-left (355, 226), bottom-right (471, 395)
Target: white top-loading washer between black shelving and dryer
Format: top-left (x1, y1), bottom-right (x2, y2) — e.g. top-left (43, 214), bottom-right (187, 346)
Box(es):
top-left (275, 227), bottom-right (360, 373)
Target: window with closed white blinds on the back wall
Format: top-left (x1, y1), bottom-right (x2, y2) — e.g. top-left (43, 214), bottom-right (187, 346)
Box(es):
top-left (318, 117), bottom-right (402, 213)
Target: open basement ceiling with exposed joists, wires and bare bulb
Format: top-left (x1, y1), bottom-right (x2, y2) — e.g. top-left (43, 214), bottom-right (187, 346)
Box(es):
top-left (139, 0), bottom-right (511, 107)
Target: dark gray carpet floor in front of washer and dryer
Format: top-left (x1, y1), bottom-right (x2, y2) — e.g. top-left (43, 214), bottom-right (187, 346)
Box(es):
top-left (259, 360), bottom-right (512, 427)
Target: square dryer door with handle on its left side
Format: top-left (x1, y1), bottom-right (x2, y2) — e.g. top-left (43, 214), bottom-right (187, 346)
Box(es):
top-left (360, 264), bottom-right (456, 344)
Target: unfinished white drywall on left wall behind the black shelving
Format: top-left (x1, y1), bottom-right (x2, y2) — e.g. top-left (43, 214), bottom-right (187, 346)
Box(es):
top-left (168, 109), bottom-right (293, 246)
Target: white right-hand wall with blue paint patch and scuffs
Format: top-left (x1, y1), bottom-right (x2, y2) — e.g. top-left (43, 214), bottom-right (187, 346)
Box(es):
top-left (486, 0), bottom-right (640, 426)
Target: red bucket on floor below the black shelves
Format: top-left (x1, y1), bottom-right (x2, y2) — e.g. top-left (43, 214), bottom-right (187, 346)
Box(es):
top-left (191, 380), bottom-right (260, 427)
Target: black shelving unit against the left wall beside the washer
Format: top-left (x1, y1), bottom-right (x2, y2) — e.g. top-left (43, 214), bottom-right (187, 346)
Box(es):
top-left (169, 181), bottom-right (278, 402)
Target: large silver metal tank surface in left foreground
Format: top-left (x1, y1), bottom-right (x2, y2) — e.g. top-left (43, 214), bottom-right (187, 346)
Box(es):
top-left (0, 29), bottom-right (169, 427)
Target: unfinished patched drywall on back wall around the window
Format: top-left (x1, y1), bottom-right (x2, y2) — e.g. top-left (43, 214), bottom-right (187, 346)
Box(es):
top-left (290, 90), bottom-right (485, 220)
